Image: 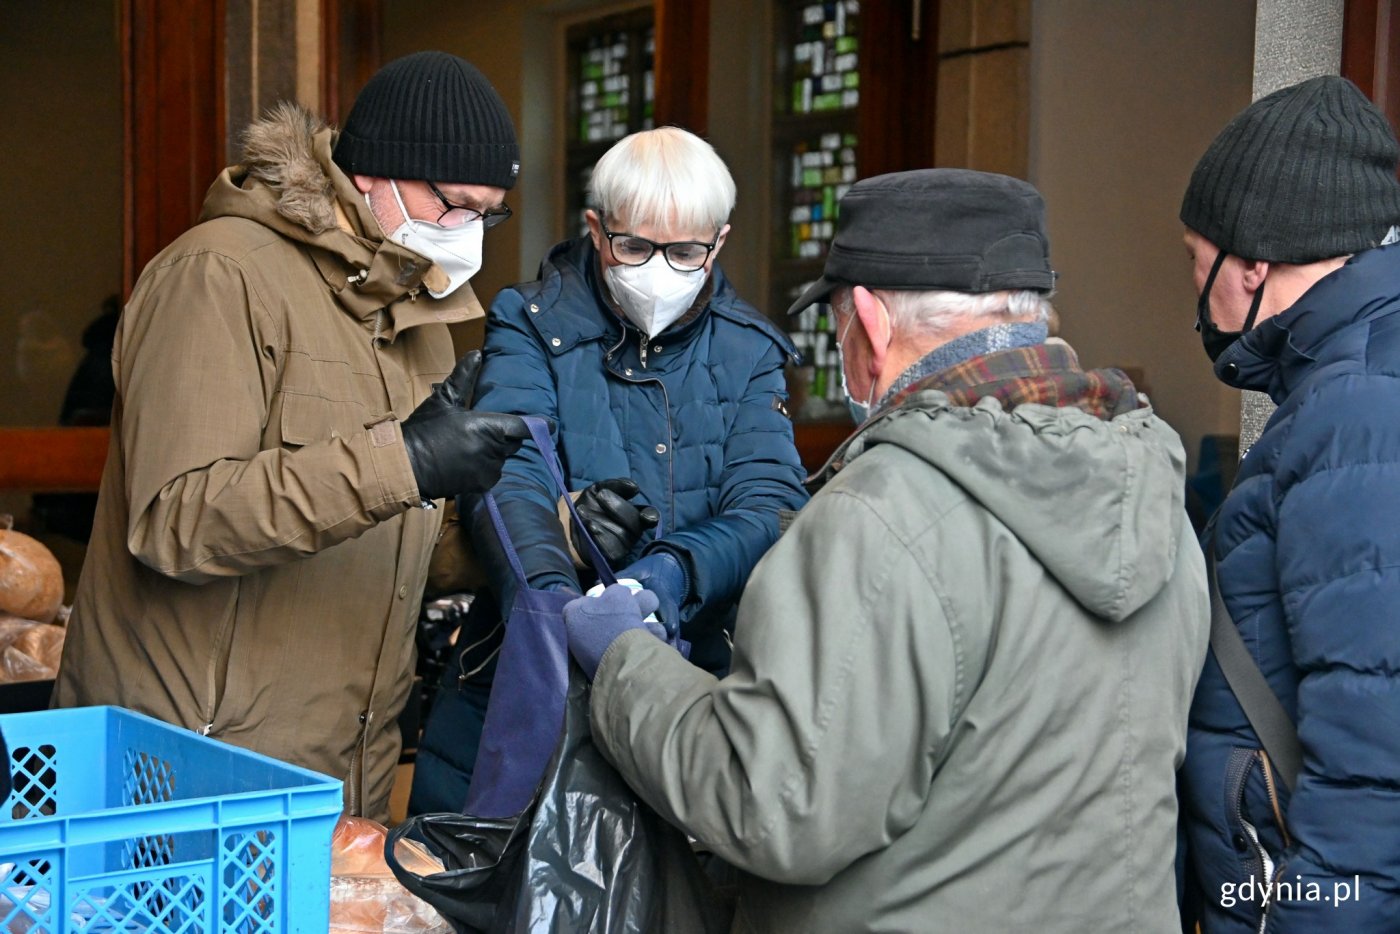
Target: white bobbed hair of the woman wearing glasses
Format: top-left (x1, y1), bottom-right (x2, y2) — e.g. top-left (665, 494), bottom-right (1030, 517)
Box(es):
top-left (588, 126), bottom-right (735, 238)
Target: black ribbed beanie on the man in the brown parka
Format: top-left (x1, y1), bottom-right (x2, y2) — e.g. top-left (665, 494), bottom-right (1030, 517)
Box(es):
top-left (332, 52), bottom-right (521, 188)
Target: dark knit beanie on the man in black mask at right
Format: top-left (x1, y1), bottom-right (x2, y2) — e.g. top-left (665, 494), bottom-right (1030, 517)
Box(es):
top-left (1182, 76), bottom-right (1400, 263)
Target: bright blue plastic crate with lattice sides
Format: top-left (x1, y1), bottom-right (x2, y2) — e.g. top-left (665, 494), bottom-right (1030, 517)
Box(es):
top-left (0, 707), bottom-right (342, 934)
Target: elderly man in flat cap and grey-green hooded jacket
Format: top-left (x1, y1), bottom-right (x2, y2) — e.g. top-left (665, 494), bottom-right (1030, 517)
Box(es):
top-left (551, 169), bottom-right (1210, 934)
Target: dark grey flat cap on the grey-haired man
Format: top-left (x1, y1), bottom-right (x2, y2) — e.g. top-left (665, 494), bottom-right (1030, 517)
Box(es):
top-left (788, 168), bottom-right (1054, 315)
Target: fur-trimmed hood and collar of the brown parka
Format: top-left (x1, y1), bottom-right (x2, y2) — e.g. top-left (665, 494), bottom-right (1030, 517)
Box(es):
top-left (199, 104), bottom-right (484, 342)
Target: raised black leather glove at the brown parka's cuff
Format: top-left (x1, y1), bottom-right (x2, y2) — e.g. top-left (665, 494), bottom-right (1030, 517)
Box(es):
top-left (403, 350), bottom-right (529, 500)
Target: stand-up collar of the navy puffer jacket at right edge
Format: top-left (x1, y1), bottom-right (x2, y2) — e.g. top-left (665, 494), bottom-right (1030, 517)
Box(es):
top-left (1215, 244), bottom-right (1400, 405)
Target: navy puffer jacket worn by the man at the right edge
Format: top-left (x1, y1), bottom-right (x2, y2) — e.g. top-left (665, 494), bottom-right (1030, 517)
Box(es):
top-left (1183, 245), bottom-right (1400, 934)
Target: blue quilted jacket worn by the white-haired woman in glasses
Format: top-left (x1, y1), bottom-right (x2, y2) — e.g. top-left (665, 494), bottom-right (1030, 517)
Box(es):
top-left (476, 237), bottom-right (808, 669)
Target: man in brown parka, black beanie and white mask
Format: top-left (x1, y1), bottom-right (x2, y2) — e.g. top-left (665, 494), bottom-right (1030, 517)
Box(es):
top-left (55, 52), bottom-right (543, 821)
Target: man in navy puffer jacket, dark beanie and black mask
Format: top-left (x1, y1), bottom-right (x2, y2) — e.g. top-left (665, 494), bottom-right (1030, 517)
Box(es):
top-left (1182, 76), bottom-right (1400, 934)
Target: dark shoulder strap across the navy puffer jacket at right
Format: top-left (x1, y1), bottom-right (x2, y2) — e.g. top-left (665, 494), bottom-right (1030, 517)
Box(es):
top-left (1205, 528), bottom-right (1303, 791)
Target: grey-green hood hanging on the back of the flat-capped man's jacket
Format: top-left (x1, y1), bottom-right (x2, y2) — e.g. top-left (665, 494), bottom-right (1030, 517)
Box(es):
top-left (840, 389), bottom-right (1186, 622)
